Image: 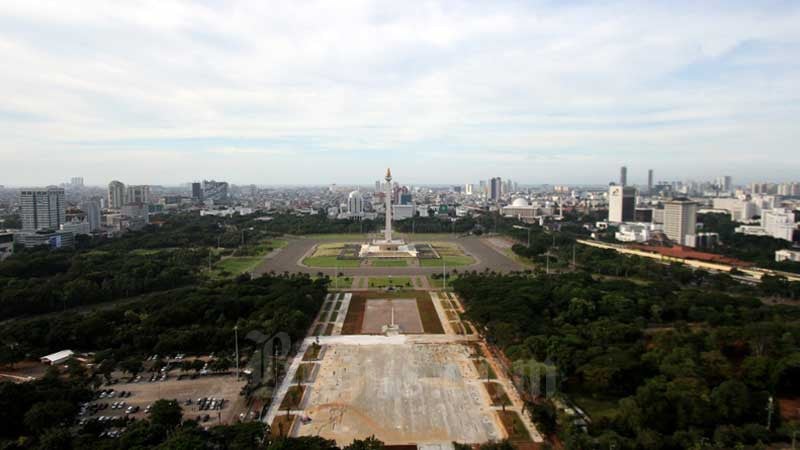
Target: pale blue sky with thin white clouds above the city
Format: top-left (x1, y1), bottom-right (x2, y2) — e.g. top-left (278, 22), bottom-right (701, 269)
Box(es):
top-left (0, 0), bottom-right (800, 186)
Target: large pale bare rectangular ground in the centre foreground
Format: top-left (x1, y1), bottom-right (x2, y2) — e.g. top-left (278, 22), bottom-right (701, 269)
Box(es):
top-left (295, 344), bottom-right (502, 445)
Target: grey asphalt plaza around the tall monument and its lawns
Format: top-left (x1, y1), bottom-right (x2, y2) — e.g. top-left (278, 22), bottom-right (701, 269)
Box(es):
top-left (253, 236), bottom-right (525, 276)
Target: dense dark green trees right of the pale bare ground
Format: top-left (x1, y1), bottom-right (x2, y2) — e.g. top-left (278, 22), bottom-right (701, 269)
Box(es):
top-left (453, 272), bottom-right (800, 449)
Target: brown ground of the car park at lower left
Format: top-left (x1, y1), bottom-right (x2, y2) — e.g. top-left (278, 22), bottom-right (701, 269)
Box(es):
top-left (90, 375), bottom-right (248, 426)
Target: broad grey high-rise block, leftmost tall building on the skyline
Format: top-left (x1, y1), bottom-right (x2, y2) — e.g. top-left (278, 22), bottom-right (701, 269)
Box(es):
top-left (19, 186), bottom-right (67, 231)
